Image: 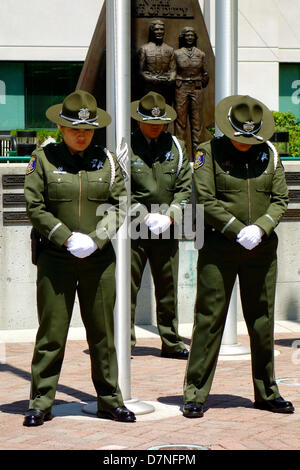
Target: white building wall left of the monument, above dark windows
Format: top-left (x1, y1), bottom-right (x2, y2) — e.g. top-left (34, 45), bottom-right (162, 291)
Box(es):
top-left (0, 0), bottom-right (103, 61)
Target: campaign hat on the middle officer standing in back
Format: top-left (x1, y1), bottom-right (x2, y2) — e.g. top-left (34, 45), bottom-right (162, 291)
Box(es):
top-left (131, 91), bottom-right (177, 124)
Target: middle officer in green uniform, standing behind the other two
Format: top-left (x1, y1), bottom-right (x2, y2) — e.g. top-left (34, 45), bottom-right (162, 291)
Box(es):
top-left (131, 92), bottom-right (192, 359)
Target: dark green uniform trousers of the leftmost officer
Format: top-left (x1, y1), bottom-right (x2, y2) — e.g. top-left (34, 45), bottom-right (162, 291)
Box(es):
top-left (29, 245), bottom-right (123, 411)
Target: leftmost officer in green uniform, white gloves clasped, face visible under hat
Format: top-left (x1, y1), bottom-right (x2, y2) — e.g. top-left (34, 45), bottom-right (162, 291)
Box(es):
top-left (24, 90), bottom-right (135, 426)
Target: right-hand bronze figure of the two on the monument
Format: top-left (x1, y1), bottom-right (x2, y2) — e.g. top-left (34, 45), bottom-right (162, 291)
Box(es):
top-left (174, 26), bottom-right (209, 156)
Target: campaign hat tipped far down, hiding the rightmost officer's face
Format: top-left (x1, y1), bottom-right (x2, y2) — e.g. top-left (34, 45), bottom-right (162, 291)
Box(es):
top-left (215, 95), bottom-right (275, 145)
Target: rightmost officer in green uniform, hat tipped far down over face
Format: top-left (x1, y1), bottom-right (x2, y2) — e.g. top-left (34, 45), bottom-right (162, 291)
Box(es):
top-left (183, 96), bottom-right (294, 418)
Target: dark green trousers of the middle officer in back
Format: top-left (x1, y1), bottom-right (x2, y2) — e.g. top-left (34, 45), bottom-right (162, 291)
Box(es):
top-left (131, 239), bottom-right (185, 352)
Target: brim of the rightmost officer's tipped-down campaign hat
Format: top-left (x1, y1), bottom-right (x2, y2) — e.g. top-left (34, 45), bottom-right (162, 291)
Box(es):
top-left (215, 95), bottom-right (275, 145)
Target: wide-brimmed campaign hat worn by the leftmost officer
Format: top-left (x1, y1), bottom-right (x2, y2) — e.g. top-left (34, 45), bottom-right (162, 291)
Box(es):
top-left (46, 90), bottom-right (111, 130)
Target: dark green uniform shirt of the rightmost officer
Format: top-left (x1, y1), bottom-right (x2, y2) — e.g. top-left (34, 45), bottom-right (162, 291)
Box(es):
top-left (194, 136), bottom-right (288, 240)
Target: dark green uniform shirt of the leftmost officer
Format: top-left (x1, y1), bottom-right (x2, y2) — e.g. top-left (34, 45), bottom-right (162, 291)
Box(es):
top-left (25, 143), bottom-right (126, 249)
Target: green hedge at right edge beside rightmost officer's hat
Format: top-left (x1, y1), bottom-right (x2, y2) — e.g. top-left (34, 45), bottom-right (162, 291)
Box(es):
top-left (272, 111), bottom-right (300, 157)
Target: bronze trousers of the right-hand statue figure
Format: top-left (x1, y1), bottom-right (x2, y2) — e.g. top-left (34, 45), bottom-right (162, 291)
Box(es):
top-left (175, 82), bottom-right (203, 155)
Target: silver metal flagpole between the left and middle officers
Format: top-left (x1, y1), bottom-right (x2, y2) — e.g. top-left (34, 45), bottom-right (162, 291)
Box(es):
top-left (84, 0), bottom-right (154, 415)
